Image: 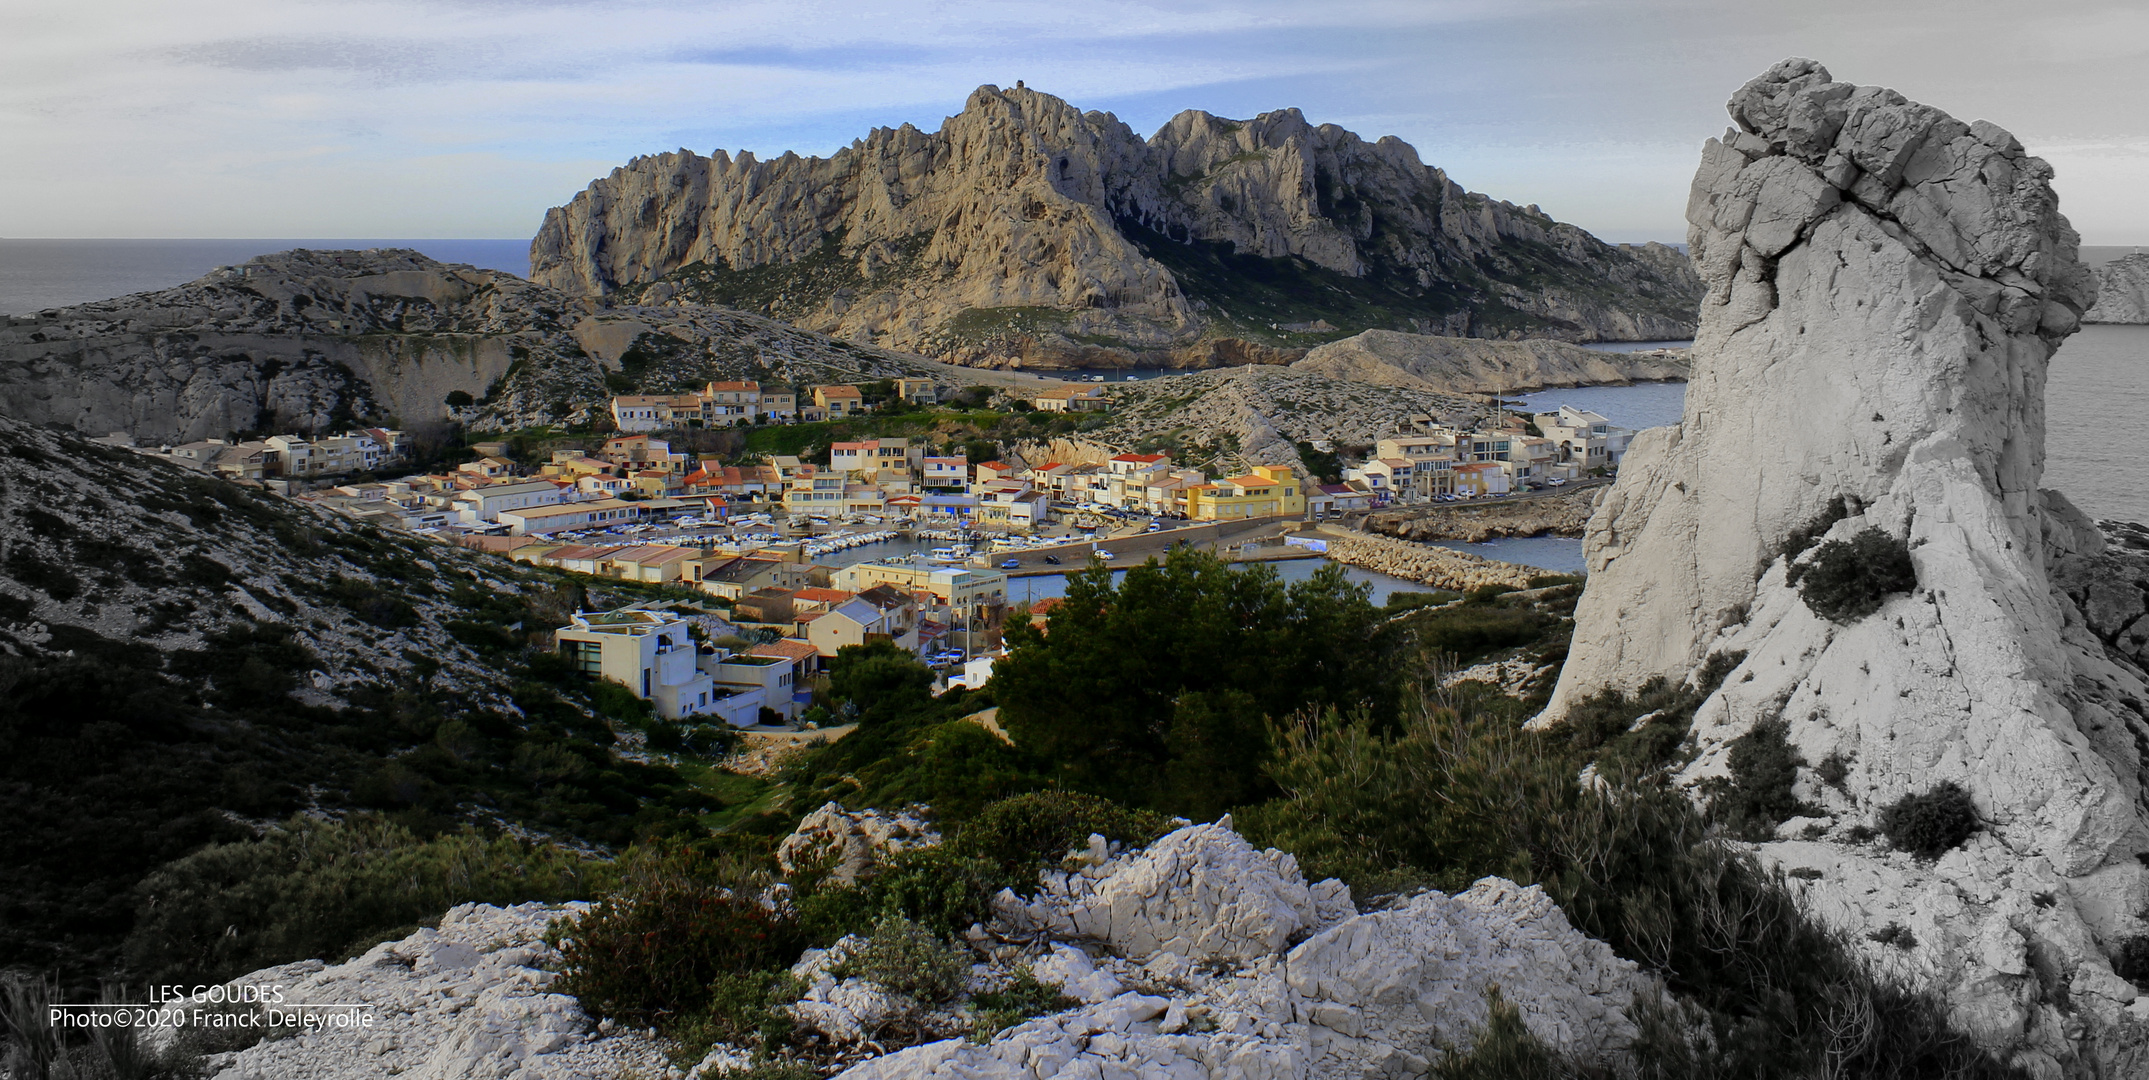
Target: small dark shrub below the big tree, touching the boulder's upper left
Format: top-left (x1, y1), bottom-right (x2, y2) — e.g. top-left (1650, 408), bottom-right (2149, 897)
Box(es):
top-left (950, 792), bottom-right (1171, 895)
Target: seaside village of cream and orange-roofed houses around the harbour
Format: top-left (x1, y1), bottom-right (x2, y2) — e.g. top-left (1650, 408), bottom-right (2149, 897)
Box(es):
top-left (79, 378), bottom-right (1633, 728)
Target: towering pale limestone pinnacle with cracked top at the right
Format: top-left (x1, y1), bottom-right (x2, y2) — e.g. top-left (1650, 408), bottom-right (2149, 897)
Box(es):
top-left (1545, 60), bottom-right (2149, 1076)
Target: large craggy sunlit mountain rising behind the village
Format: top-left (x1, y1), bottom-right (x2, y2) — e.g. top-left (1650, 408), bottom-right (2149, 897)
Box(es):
top-left (531, 84), bottom-right (1700, 367)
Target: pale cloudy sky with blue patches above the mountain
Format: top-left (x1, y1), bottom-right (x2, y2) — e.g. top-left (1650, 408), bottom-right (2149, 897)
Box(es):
top-left (0, 0), bottom-right (2149, 245)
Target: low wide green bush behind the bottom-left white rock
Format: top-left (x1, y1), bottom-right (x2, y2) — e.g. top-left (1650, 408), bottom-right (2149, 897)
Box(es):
top-left (127, 816), bottom-right (610, 983)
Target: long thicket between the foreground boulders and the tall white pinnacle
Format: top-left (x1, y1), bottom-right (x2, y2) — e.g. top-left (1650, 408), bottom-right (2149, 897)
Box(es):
top-left (1244, 702), bottom-right (2005, 1080)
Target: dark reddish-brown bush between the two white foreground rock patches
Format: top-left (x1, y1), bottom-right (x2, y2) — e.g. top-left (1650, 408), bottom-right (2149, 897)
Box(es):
top-left (554, 844), bottom-right (804, 1024)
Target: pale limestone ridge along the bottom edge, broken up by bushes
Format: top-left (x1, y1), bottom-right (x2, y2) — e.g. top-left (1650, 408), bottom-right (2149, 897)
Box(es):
top-left (197, 812), bottom-right (1659, 1080)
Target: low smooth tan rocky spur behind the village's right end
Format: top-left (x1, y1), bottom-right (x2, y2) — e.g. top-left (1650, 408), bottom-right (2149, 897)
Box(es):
top-left (1292, 331), bottom-right (1687, 393)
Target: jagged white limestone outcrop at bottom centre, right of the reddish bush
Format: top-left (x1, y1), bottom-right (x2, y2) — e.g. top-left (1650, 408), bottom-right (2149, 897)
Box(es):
top-left (825, 818), bottom-right (1657, 1080)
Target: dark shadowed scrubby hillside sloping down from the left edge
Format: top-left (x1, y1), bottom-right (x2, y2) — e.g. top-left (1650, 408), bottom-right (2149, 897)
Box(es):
top-left (0, 419), bottom-right (716, 986)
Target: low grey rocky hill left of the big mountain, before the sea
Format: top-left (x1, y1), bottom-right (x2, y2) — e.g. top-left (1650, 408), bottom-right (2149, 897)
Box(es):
top-left (0, 249), bottom-right (946, 442)
